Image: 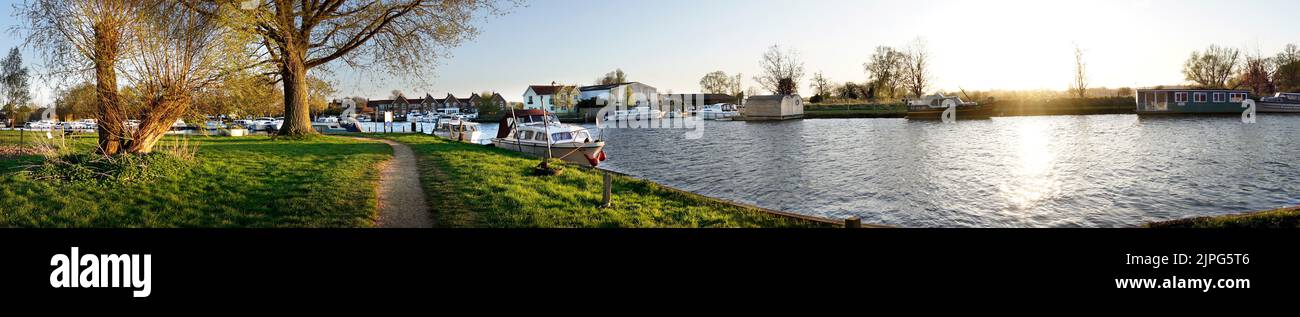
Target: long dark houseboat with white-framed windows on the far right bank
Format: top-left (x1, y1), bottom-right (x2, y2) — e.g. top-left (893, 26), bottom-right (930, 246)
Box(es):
top-left (1135, 88), bottom-right (1251, 113)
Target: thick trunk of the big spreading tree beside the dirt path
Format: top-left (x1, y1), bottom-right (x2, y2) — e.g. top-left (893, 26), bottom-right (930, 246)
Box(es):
top-left (280, 48), bottom-right (316, 136)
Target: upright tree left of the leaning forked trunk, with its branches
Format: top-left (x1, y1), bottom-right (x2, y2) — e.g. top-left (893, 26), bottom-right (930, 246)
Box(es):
top-left (18, 0), bottom-right (156, 155)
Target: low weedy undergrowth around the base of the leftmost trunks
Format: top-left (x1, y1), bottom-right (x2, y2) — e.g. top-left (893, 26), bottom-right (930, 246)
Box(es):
top-left (29, 152), bottom-right (192, 183)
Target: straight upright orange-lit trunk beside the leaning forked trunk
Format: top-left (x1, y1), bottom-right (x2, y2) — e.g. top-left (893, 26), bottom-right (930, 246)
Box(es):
top-left (95, 52), bottom-right (126, 156)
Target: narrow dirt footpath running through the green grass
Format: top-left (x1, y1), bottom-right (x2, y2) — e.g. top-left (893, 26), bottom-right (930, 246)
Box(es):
top-left (365, 139), bottom-right (433, 227)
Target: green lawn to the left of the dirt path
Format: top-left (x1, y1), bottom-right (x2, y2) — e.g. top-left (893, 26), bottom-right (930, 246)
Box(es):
top-left (0, 131), bottom-right (391, 227)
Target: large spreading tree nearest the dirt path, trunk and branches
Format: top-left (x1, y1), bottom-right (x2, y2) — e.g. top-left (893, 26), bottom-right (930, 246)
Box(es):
top-left (185, 0), bottom-right (519, 135)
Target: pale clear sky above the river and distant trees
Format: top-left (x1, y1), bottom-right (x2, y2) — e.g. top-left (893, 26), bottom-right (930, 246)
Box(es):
top-left (0, 0), bottom-right (1300, 104)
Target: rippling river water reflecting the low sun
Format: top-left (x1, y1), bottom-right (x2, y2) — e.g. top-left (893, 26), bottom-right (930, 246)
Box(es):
top-left (602, 114), bottom-right (1300, 227)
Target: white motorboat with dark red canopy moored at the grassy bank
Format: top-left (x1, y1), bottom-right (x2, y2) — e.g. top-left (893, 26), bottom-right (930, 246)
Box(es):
top-left (491, 109), bottom-right (606, 166)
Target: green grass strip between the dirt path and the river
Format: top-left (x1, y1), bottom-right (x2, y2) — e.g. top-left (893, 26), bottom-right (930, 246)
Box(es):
top-left (356, 135), bottom-right (827, 227)
